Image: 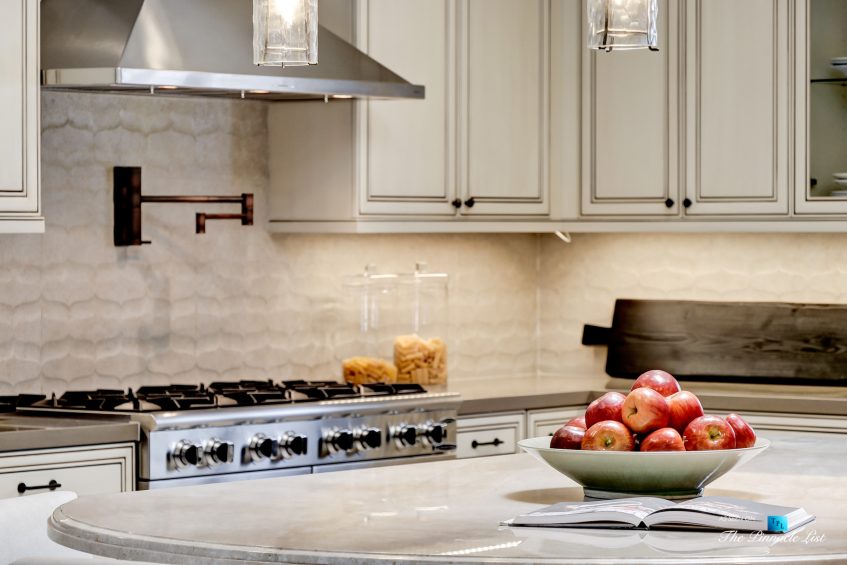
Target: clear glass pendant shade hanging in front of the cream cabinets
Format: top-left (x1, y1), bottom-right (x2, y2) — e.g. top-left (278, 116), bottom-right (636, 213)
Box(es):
top-left (586, 0), bottom-right (659, 51)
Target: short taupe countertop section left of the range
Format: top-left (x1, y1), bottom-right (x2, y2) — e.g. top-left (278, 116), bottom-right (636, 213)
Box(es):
top-left (0, 413), bottom-right (140, 452)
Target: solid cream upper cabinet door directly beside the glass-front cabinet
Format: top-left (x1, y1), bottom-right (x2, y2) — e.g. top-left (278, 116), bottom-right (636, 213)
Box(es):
top-left (686, 0), bottom-right (792, 216)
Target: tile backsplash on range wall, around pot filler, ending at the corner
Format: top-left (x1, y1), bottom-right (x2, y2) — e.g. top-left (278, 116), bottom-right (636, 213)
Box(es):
top-left (0, 93), bottom-right (537, 393)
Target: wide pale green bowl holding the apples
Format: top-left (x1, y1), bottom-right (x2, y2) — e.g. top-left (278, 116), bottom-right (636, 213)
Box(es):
top-left (518, 436), bottom-right (770, 498)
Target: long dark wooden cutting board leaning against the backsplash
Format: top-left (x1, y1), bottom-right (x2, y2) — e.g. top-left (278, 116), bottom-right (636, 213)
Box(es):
top-left (583, 299), bottom-right (847, 385)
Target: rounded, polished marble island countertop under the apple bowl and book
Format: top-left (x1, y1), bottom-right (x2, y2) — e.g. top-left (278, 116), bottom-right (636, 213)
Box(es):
top-left (49, 431), bottom-right (847, 565)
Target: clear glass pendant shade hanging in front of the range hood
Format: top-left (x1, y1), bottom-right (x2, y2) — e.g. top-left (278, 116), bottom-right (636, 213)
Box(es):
top-left (253, 0), bottom-right (318, 67)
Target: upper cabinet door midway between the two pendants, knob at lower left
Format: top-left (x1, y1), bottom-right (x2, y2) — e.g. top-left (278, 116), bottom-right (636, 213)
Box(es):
top-left (460, 0), bottom-right (551, 215)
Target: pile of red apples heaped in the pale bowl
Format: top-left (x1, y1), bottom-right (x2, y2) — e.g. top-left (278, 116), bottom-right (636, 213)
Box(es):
top-left (550, 369), bottom-right (756, 451)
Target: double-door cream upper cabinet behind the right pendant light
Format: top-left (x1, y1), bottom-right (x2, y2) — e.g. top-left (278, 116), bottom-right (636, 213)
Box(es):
top-left (581, 0), bottom-right (793, 219)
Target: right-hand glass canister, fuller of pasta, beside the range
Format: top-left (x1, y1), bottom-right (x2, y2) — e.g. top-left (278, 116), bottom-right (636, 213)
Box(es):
top-left (394, 262), bottom-right (450, 386)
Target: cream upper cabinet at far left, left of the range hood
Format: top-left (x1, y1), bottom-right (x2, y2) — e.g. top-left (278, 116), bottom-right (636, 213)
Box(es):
top-left (0, 0), bottom-right (44, 233)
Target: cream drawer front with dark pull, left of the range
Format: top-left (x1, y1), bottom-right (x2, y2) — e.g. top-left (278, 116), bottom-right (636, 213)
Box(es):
top-left (0, 462), bottom-right (123, 498)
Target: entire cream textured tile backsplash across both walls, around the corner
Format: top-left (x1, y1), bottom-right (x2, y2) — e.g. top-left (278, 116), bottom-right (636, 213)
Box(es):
top-left (0, 93), bottom-right (847, 393)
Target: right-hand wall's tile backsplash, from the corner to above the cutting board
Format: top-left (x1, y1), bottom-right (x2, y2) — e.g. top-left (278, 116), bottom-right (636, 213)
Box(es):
top-left (538, 233), bottom-right (847, 375)
